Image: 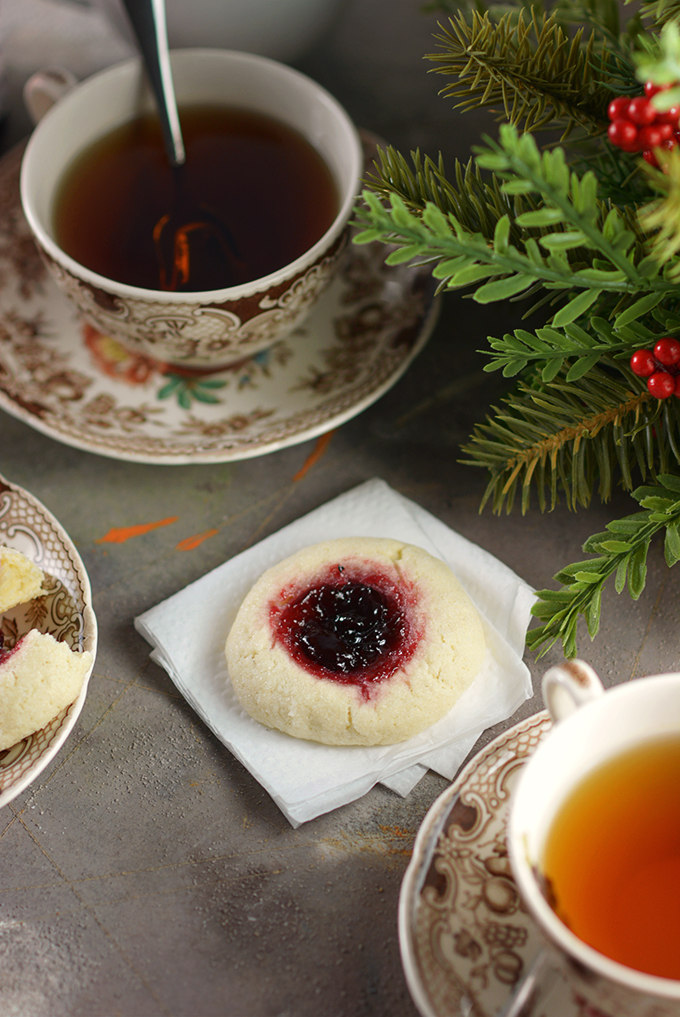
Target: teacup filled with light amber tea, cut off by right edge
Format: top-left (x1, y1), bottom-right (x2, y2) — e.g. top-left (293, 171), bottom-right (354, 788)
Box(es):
top-left (507, 661), bottom-right (680, 1017)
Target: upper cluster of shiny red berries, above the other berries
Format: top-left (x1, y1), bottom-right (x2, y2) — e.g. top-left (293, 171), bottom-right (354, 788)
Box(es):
top-left (607, 81), bottom-right (680, 166)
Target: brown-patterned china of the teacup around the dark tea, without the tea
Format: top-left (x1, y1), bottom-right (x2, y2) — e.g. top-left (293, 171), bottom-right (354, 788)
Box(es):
top-left (20, 49), bottom-right (363, 370)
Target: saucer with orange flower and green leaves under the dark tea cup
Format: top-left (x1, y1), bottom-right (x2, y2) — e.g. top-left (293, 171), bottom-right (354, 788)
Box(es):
top-left (0, 140), bottom-right (439, 464)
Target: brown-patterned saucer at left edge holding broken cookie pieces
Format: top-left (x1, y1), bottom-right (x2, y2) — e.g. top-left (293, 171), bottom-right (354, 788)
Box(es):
top-left (0, 476), bottom-right (97, 806)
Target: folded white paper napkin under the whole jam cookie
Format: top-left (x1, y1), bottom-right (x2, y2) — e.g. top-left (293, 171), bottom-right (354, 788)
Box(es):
top-left (134, 479), bottom-right (535, 826)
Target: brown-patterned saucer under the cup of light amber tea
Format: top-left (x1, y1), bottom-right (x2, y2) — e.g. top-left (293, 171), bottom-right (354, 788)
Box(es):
top-left (399, 711), bottom-right (592, 1017)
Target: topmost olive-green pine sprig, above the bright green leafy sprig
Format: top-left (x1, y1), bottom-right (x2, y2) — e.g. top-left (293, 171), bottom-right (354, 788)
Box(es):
top-left (428, 8), bottom-right (635, 138)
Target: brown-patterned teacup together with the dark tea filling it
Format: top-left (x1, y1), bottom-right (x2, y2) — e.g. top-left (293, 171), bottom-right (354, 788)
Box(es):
top-left (20, 50), bottom-right (363, 370)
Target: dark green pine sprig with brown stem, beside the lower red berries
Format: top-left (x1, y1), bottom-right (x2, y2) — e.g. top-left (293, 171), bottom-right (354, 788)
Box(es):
top-left (462, 360), bottom-right (680, 514)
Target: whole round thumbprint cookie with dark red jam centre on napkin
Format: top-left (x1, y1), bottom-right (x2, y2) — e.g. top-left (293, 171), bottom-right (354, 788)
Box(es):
top-left (226, 537), bottom-right (485, 745)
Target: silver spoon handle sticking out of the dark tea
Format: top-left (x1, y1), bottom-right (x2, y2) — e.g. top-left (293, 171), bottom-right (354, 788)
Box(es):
top-left (118, 0), bottom-right (186, 166)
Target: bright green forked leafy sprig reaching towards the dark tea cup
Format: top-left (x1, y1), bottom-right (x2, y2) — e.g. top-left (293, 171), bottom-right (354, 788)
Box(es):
top-left (355, 124), bottom-right (676, 326)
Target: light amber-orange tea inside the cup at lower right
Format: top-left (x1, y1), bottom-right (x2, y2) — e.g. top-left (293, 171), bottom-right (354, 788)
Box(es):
top-left (543, 734), bottom-right (680, 978)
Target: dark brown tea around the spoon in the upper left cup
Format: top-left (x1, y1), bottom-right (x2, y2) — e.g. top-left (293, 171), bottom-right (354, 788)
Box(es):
top-left (54, 106), bottom-right (338, 292)
